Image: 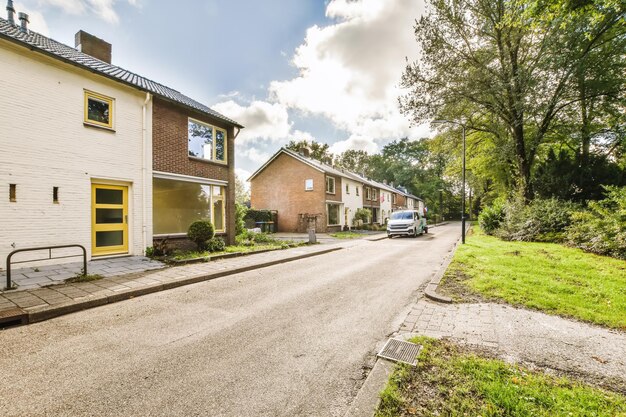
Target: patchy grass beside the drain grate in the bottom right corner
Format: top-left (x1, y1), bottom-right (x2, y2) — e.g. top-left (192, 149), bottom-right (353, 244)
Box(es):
top-left (376, 337), bottom-right (626, 417)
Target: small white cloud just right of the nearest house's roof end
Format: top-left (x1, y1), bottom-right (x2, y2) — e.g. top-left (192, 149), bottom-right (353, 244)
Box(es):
top-left (211, 100), bottom-right (292, 144)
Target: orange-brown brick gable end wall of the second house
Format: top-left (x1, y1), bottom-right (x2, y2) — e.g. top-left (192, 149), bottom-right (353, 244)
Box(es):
top-left (250, 153), bottom-right (324, 232)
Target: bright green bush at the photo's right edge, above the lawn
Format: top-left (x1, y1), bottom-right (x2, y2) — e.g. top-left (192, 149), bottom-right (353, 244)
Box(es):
top-left (567, 186), bottom-right (626, 259)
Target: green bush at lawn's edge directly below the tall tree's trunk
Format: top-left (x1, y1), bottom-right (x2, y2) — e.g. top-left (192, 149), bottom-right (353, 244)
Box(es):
top-left (496, 198), bottom-right (578, 242)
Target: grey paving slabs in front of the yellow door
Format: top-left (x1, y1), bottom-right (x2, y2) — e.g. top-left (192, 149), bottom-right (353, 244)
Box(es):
top-left (0, 256), bottom-right (165, 290)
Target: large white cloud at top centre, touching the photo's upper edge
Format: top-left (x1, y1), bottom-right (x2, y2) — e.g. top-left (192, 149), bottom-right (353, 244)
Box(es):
top-left (269, 0), bottom-right (423, 150)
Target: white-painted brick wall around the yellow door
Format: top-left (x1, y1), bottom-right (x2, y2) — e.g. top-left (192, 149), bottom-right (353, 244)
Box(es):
top-left (0, 40), bottom-right (152, 267)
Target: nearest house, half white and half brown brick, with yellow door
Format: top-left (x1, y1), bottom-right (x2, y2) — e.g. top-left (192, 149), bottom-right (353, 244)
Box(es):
top-left (0, 9), bottom-right (243, 259)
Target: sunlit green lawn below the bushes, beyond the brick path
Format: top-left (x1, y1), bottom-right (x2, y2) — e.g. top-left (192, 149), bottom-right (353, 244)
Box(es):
top-left (440, 227), bottom-right (626, 330)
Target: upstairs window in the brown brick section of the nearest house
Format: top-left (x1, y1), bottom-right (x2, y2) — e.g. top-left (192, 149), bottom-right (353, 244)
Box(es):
top-left (187, 119), bottom-right (226, 162)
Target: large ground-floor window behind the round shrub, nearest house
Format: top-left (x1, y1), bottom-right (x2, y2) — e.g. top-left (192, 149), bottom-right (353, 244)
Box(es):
top-left (152, 178), bottom-right (226, 235)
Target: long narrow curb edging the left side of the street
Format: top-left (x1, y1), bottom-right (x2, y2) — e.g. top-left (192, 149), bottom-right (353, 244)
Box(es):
top-left (7, 247), bottom-right (344, 324)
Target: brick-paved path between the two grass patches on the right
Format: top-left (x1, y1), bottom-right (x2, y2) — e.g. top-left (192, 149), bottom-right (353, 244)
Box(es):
top-left (400, 299), bottom-right (626, 386)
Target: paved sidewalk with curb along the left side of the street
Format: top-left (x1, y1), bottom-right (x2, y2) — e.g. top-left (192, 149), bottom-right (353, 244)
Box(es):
top-left (0, 245), bottom-right (343, 328)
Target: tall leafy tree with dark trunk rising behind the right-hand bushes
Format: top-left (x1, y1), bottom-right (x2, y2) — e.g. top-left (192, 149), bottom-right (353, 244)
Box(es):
top-left (400, 0), bottom-right (625, 199)
